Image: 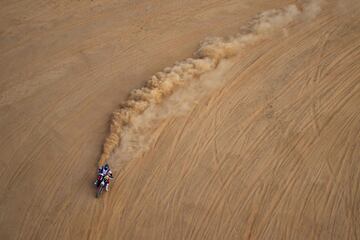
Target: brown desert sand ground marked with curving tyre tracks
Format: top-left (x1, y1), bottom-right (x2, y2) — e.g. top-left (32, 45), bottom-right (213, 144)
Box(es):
top-left (0, 0), bottom-right (360, 239)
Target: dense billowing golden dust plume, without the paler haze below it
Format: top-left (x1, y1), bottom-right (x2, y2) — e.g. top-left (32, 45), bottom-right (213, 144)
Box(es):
top-left (99, 1), bottom-right (320, 165)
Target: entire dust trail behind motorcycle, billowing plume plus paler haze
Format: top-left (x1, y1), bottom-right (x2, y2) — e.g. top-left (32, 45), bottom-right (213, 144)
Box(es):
top-left (99, 1), bottom-right (320, 168)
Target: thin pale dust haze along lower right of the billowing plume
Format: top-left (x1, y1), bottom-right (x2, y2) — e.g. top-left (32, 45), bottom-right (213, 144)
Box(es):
top-left (109, 59), bottom-right (233, 170)
